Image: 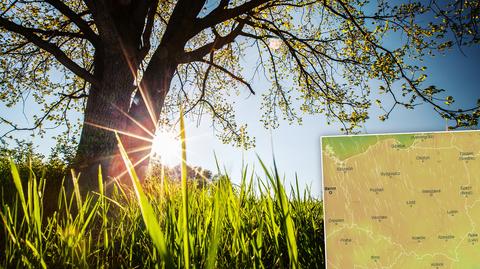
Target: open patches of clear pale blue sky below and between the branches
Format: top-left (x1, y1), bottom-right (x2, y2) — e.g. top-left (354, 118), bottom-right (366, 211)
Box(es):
top-left (0, 4), bottom-right (480, 197)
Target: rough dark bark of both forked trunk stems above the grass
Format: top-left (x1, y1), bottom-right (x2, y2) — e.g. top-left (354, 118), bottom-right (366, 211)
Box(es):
top-left (76, 0), bottom-right (188, 190)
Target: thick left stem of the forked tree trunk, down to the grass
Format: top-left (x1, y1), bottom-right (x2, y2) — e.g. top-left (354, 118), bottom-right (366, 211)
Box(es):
top-left (74, 0), bottom-right (163, 191)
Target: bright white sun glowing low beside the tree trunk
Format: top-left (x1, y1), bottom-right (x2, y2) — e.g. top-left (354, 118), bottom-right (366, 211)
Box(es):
top-left (152, 129), bottom-right (181, 167)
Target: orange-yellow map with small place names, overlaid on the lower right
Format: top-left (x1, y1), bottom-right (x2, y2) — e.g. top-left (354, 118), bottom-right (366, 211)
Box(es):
top-left (322, 131), bottom-right (480, 269)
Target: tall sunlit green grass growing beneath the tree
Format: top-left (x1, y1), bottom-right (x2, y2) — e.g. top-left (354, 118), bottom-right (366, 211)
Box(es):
top-left (0, 155), bottom-right (324, 268)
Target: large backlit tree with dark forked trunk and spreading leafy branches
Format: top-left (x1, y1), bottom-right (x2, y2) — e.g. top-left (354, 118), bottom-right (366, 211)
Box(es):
top-left (0, 0), bottom-right (480, 188)
